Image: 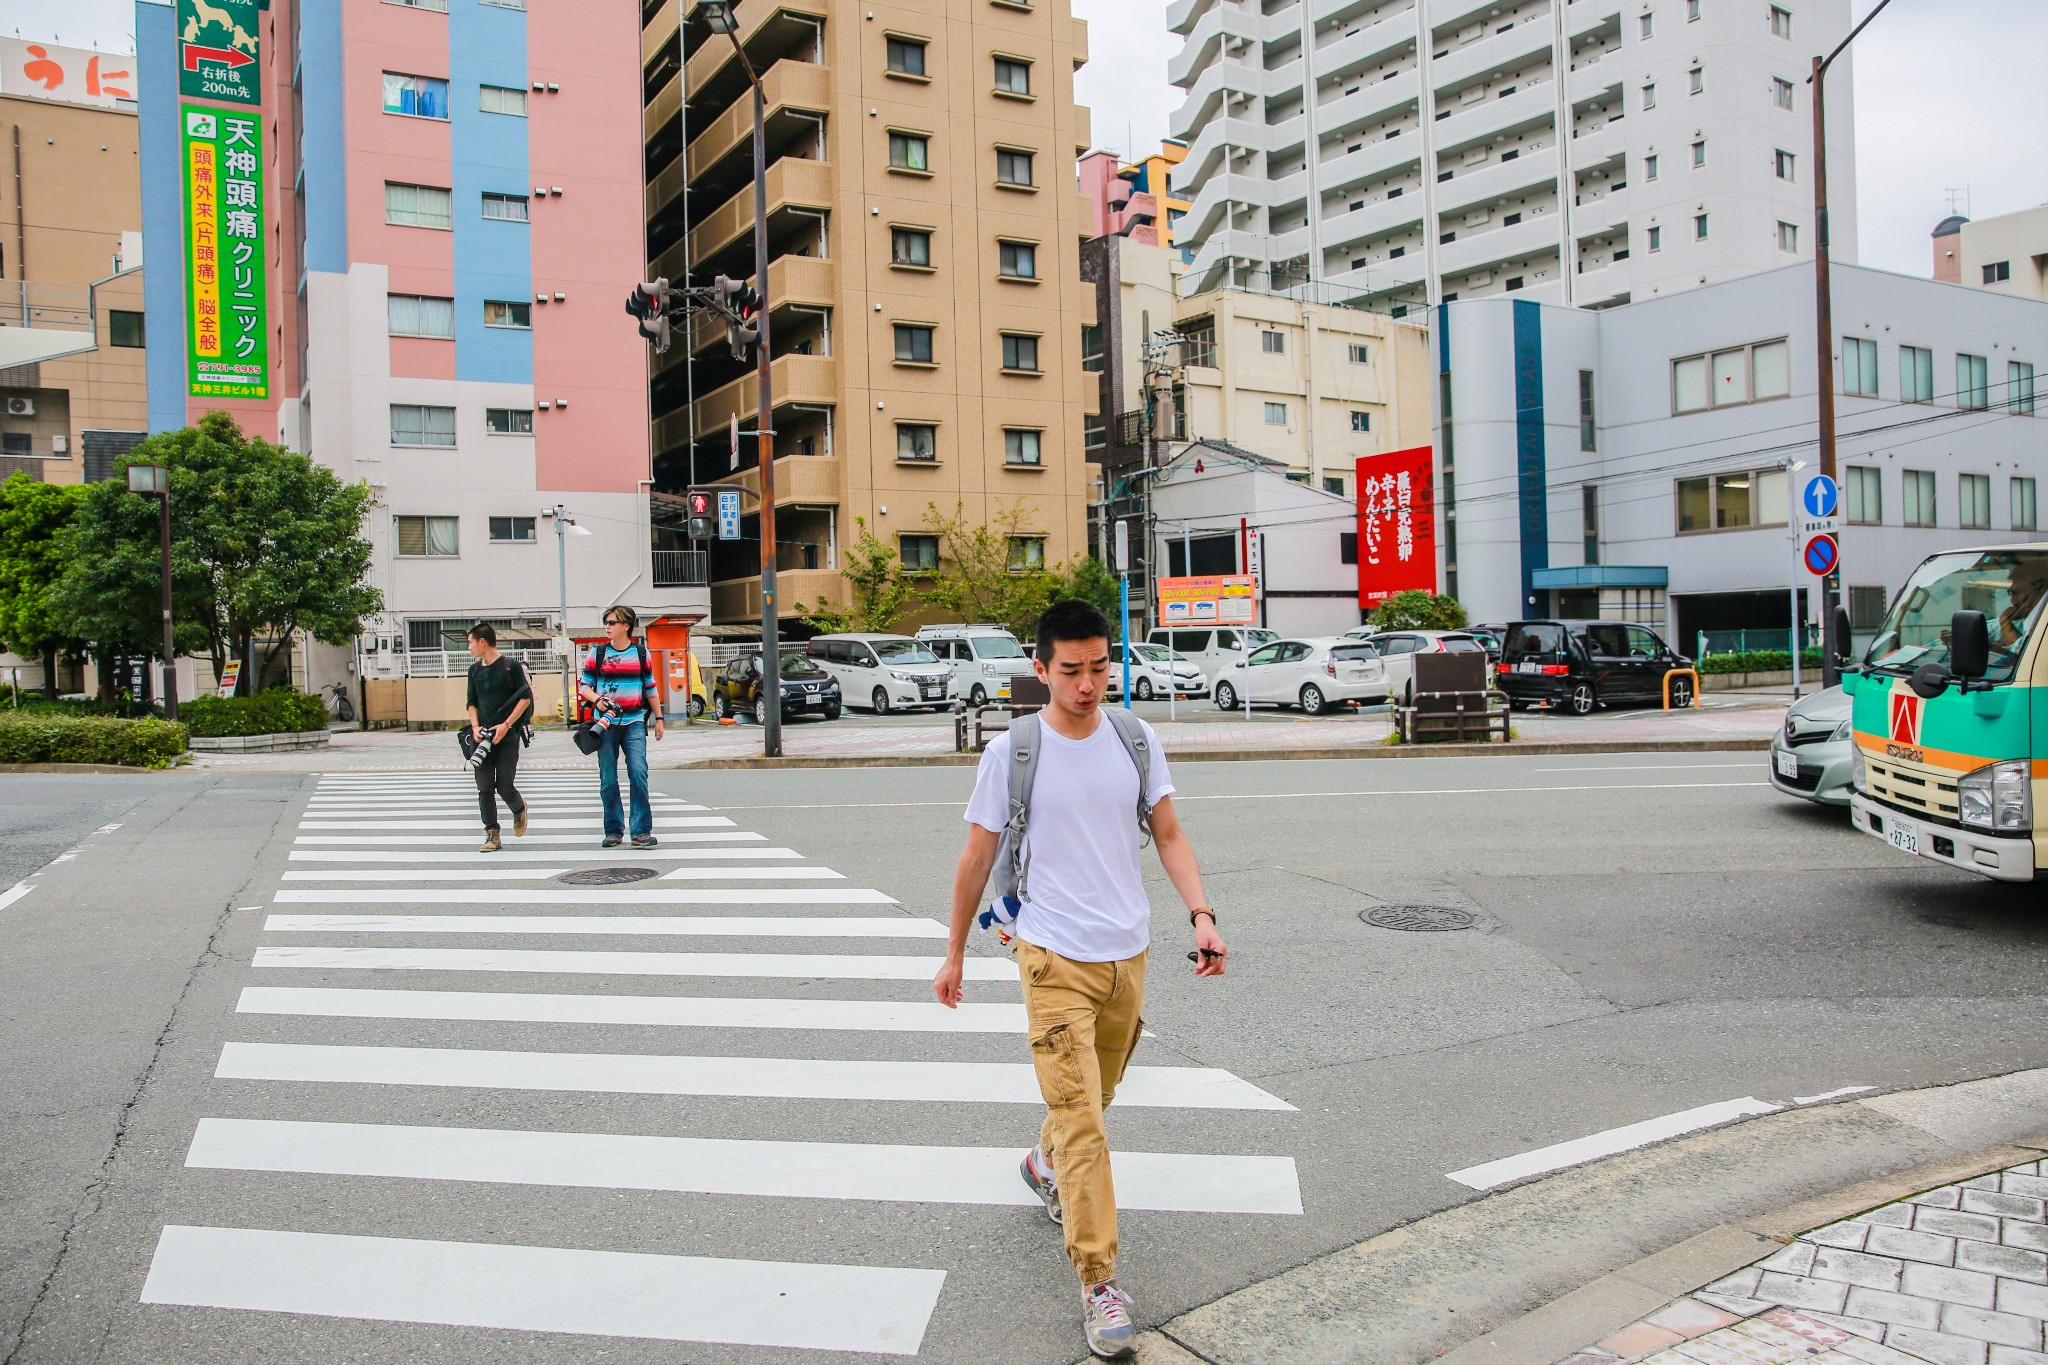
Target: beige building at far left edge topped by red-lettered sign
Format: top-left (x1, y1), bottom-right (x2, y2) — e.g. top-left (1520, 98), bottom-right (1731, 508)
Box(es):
top-left (0, 43), bottom-right (147, 483)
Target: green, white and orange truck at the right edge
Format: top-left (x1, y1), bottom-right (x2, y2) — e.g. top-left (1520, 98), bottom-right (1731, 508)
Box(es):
top-left (1841, 544), bottom-right (2048, 882)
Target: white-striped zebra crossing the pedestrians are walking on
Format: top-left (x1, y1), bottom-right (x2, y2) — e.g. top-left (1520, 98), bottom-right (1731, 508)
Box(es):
top-left (141, 772), bottom-right (1303, 1359)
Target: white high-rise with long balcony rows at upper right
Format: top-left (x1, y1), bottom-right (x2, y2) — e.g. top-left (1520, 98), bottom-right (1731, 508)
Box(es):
top-left (1167, 0), bottom-right (1855, 313)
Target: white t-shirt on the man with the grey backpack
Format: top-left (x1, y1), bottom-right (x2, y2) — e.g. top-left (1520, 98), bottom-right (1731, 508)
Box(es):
top-left (967, 716), bottom-right (1174, 962)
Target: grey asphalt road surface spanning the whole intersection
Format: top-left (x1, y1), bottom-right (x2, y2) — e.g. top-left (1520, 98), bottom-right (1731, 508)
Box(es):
top-left (0, 755), bottom-right (2048, 1365)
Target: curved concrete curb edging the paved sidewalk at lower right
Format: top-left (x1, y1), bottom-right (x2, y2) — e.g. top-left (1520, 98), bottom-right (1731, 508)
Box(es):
top-left (1139, 1070), bottom-right (2048, 1365)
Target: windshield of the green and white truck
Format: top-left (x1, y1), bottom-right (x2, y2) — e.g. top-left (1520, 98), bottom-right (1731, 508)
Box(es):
top-left (1864, 551), bottom-right (2048, 684)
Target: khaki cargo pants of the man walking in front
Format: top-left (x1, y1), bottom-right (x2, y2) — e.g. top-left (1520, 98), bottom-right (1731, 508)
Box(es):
top-left (1018, 939), bottom-right (1145, 1285)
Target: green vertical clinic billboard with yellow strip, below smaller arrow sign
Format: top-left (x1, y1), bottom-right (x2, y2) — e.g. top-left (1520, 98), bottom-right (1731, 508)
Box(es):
top-left (178, 104), bottom-right (270, 399)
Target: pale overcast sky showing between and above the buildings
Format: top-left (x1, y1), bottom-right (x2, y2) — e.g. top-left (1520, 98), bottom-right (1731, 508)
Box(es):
top-left (6, 0), bottom-right (2048, 274)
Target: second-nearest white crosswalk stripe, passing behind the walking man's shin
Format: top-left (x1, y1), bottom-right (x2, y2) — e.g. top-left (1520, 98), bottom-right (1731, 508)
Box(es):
top-left (184, 1117), bottom-right (1300, 1214)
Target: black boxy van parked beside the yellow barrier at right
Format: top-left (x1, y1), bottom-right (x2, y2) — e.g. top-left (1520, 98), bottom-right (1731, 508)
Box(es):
top-left (1497, 620), bottom-right (1694, 716)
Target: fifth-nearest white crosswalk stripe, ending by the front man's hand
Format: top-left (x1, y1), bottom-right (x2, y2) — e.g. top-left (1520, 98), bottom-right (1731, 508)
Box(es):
top-left (250, 948), bottom-right (1018, 984)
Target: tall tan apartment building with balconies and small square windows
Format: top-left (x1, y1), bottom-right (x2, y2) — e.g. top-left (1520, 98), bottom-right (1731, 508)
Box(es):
top-left (643, 0), bottom-right (1094, 622)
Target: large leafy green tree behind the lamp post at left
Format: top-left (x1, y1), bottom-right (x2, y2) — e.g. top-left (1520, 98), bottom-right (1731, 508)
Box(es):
top-left (57, 411), bottom-right (383, 694)
